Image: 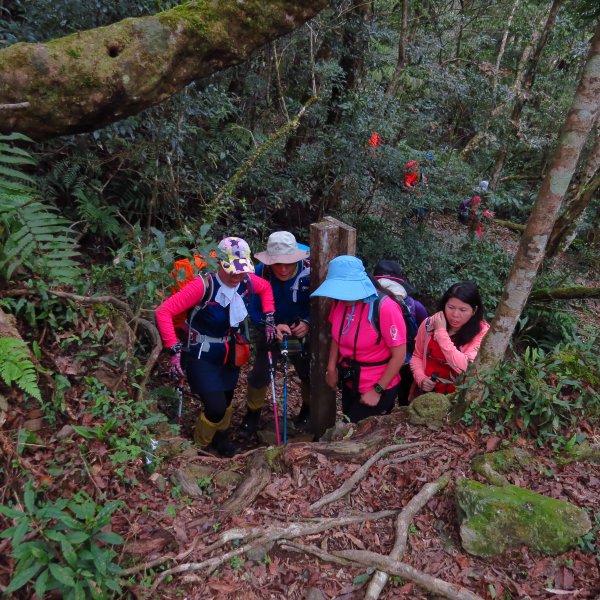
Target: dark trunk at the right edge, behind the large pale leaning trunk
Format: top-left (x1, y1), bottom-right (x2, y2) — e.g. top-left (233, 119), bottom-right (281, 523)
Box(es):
top-left (546, 124), bottom-right (600, 258)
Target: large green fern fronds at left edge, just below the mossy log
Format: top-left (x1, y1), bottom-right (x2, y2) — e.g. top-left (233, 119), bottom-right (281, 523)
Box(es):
top-left (0, 134), bottom-right (80, 285)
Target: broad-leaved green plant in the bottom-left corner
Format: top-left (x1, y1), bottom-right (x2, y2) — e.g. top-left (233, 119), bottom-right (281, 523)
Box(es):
top-left (0, 481), bottom-right (123, 600)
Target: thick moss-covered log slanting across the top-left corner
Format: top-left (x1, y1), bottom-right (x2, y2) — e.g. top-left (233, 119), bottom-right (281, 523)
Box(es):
top-left (0, 0), bottom-right (327, 140)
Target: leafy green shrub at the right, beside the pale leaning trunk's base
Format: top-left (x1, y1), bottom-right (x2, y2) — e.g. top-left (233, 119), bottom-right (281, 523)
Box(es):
top-left (457, 339), bottom-right (600, 445)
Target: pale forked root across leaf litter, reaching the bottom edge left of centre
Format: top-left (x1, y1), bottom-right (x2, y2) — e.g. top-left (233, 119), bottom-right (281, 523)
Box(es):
top-left (150, 510), bottom-right (396, 596)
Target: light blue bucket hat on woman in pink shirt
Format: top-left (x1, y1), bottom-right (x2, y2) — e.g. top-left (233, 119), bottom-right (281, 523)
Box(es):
top-left (311, 255), bottom-right (377, 301)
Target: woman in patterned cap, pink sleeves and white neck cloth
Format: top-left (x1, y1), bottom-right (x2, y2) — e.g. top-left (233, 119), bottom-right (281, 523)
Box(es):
top-left (155, 237), bottom-right (276, 456)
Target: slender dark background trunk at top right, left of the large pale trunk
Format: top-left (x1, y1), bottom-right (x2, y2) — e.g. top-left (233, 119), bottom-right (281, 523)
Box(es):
top-left (490, 0), bottom-right (562, 190)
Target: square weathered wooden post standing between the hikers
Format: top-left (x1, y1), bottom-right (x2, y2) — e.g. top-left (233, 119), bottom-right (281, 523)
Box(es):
top-left (309, 217), bottom-right (356, 439)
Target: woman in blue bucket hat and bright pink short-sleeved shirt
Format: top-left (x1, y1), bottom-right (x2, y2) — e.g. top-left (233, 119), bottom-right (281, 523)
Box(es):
top-left (312, 256), bottom-right (406, 423)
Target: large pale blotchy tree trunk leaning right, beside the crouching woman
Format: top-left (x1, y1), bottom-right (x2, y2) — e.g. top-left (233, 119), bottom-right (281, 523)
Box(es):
top-left (464, 24), bottom-right (600, 408)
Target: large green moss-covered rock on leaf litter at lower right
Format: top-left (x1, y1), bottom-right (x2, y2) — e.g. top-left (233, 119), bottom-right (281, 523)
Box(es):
top-left (456, 479), bottom-right (592, 557)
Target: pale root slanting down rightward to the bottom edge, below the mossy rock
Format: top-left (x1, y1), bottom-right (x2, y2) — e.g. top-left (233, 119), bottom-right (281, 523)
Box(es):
top-left (280, 542), bottom-right (483, 600)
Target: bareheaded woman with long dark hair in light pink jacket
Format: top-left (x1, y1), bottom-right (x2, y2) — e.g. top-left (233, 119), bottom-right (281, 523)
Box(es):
top-left (410, 282), bottom-right (490, 398)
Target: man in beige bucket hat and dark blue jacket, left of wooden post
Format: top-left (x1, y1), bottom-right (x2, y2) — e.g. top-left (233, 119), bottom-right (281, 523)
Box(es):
top-left (241, 231), bottom-right (310, 435)
